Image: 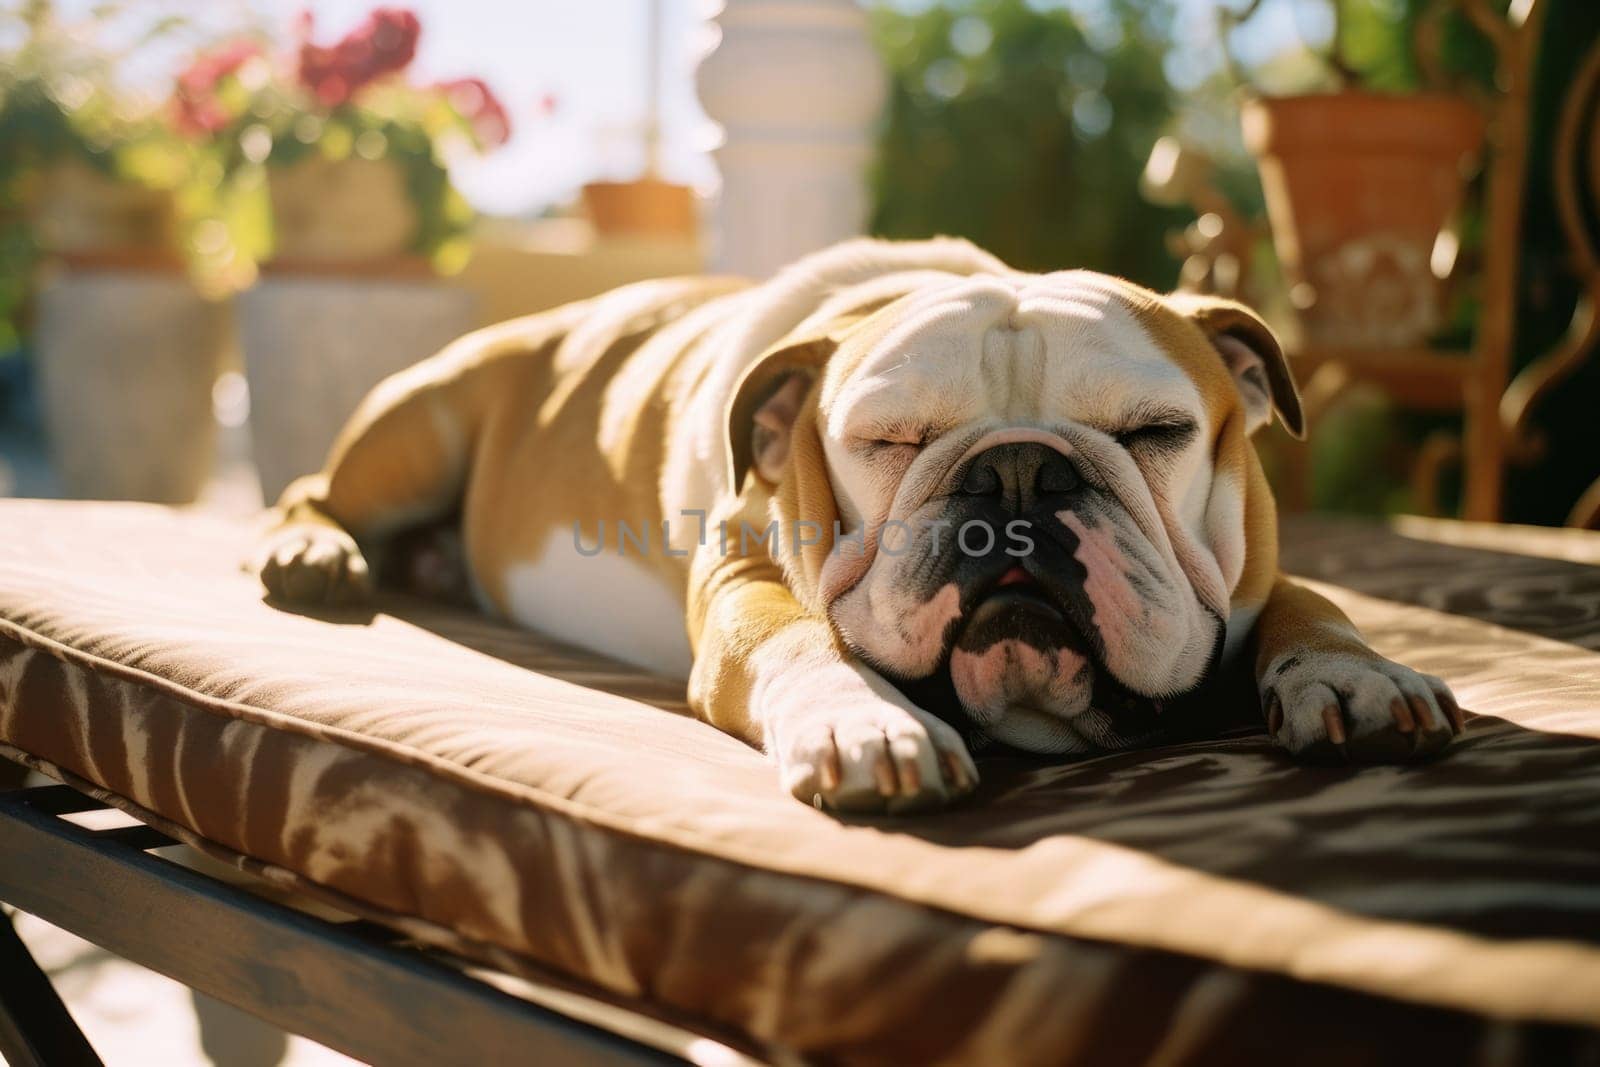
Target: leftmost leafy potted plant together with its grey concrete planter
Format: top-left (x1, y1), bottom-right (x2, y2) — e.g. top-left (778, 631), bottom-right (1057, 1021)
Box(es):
top-left (0, 3), bottom-right (226, 504)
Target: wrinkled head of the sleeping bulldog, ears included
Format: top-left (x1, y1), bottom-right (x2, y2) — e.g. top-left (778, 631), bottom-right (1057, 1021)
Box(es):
top-left (730, 272), bottom-right (1302, 753)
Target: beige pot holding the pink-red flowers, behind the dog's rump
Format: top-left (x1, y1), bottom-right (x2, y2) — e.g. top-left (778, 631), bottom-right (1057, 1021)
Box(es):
top-left (267, 155), bottom-right (418, 264)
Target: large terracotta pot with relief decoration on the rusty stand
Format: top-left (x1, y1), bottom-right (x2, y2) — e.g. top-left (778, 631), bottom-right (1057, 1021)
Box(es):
top-left (1242, 91), bottom-right (1485, 349)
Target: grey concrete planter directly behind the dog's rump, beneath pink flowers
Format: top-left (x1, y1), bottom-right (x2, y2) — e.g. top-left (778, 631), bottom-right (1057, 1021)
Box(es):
top-left (237, 274), bottom-right (477, 502)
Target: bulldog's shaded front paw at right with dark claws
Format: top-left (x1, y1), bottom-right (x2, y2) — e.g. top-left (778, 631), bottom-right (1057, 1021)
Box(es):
top-left (1261, 651), bottom-right (1466, 763)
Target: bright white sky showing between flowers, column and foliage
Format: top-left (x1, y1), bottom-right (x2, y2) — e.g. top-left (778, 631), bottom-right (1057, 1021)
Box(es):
top-left (40, 0), bottom-right (1326, 214)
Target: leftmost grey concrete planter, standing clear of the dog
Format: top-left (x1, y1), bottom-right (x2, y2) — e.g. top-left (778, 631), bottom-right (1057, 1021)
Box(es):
top-left (35, 270), bottom-right (229, 504)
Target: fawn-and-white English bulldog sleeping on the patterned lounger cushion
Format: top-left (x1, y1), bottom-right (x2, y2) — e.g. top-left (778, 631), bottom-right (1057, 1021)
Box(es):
top-left (251, 240), bottom-right (1462, 811)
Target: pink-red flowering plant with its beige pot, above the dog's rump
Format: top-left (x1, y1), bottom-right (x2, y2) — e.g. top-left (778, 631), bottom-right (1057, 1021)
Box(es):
top-left (173, 8), bottom-right (510, 286)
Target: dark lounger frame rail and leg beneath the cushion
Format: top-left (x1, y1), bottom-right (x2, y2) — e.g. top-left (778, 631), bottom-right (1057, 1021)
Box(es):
top-left (0, 785), bottom-right (675, 1067)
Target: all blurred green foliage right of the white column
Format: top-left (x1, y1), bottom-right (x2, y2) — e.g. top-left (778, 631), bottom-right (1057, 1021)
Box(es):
top-left (872, 0), bottom-right (1600, 523)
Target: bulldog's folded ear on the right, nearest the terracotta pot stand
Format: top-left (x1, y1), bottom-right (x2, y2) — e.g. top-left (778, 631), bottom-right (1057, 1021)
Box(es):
top-left (1166, 293), bottom-right (1306, 440)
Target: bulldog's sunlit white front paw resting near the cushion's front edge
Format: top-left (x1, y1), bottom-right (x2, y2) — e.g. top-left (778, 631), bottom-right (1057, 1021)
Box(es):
top-left (774, 701), bottom-right (978, 813)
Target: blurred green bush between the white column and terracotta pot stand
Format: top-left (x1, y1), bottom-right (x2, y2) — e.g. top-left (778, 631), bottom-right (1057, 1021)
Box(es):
top-left (870, 0), bottom-right (1184, 285)
